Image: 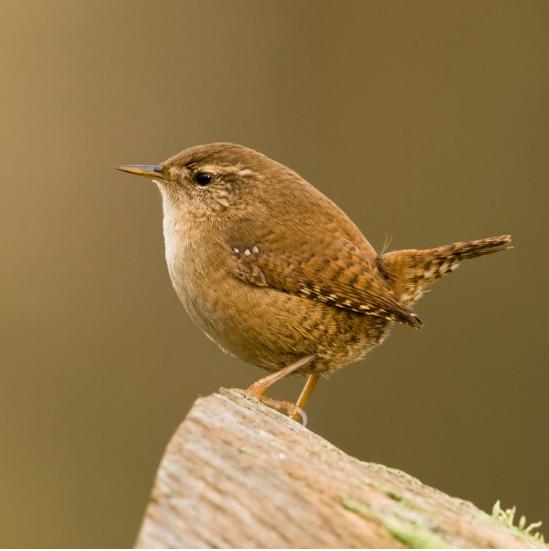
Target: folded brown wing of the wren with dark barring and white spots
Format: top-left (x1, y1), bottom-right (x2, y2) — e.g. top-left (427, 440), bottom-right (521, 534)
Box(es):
top-left (227, 236), bottom-right (421, 327)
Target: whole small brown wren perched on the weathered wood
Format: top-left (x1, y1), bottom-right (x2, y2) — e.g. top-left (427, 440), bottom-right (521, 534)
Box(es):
top-left (119, 143), bottom-right (511, 419)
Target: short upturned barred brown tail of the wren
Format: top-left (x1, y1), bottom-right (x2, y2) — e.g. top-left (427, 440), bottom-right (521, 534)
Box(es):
top-left (378, 235), bottom-right (512, 306)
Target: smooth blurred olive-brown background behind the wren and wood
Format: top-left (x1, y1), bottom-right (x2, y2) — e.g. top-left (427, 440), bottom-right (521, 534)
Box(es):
top-left (0, 0), bottom-right (549, 547)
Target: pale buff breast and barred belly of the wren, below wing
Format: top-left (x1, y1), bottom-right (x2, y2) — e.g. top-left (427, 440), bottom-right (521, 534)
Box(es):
top-left (157, 201), bottom-right (387, 371)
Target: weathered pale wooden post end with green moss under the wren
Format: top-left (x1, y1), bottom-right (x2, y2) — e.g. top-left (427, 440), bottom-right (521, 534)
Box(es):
top-left (136, 390), bottom-right (541, 548)
